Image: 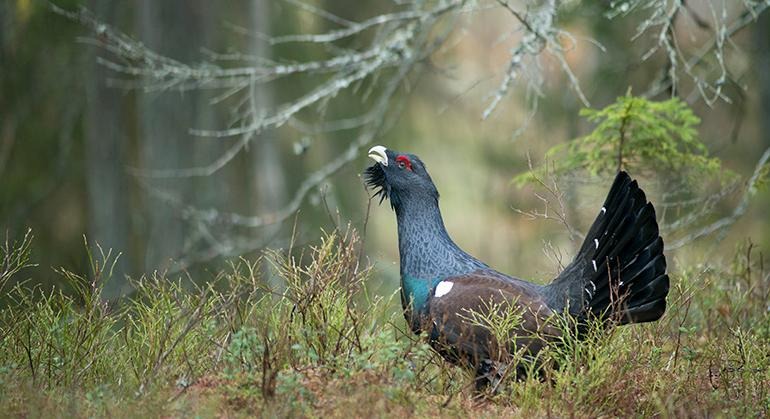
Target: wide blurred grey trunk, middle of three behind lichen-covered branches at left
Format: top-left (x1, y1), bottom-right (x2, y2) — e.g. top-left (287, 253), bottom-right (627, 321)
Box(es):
top-left (138, 0), bottom-right (217, 270)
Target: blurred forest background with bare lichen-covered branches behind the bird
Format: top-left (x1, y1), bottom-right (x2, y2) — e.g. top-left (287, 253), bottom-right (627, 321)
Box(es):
top-left (0, 0), bottom-right (770, 413)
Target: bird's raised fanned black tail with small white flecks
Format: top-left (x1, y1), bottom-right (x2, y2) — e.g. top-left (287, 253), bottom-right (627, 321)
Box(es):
top-left (545, 171), bottom-right (669, 324)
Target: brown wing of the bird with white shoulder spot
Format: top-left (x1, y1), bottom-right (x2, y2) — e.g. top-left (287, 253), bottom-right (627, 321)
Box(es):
top-left (423, 272), bottom-right (560, 366)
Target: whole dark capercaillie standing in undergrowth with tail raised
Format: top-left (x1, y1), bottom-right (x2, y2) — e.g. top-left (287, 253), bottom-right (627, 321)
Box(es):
top-left (365, 146), bottom-right (669, 389)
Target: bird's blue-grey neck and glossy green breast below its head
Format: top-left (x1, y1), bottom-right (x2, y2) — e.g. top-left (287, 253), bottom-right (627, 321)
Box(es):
top-left (395, 198), bottom-right (486, 311)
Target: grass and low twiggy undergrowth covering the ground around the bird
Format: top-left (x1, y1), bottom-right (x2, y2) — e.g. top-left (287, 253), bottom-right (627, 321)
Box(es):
top-left (0, 230), bottom-right (770, 417)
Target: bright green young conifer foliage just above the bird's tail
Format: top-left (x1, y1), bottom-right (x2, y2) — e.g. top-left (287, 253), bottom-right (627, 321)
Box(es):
top-left (514, 92), bottom-right (736, 186)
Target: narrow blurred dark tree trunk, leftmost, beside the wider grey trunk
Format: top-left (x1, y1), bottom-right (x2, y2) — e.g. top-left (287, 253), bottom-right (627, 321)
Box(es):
top-left (85, 0), bottom-right (130, 299)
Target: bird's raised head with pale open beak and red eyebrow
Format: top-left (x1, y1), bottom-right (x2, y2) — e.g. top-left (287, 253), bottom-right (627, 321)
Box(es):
top-left (364, 145), bottom-right (438, 209)
